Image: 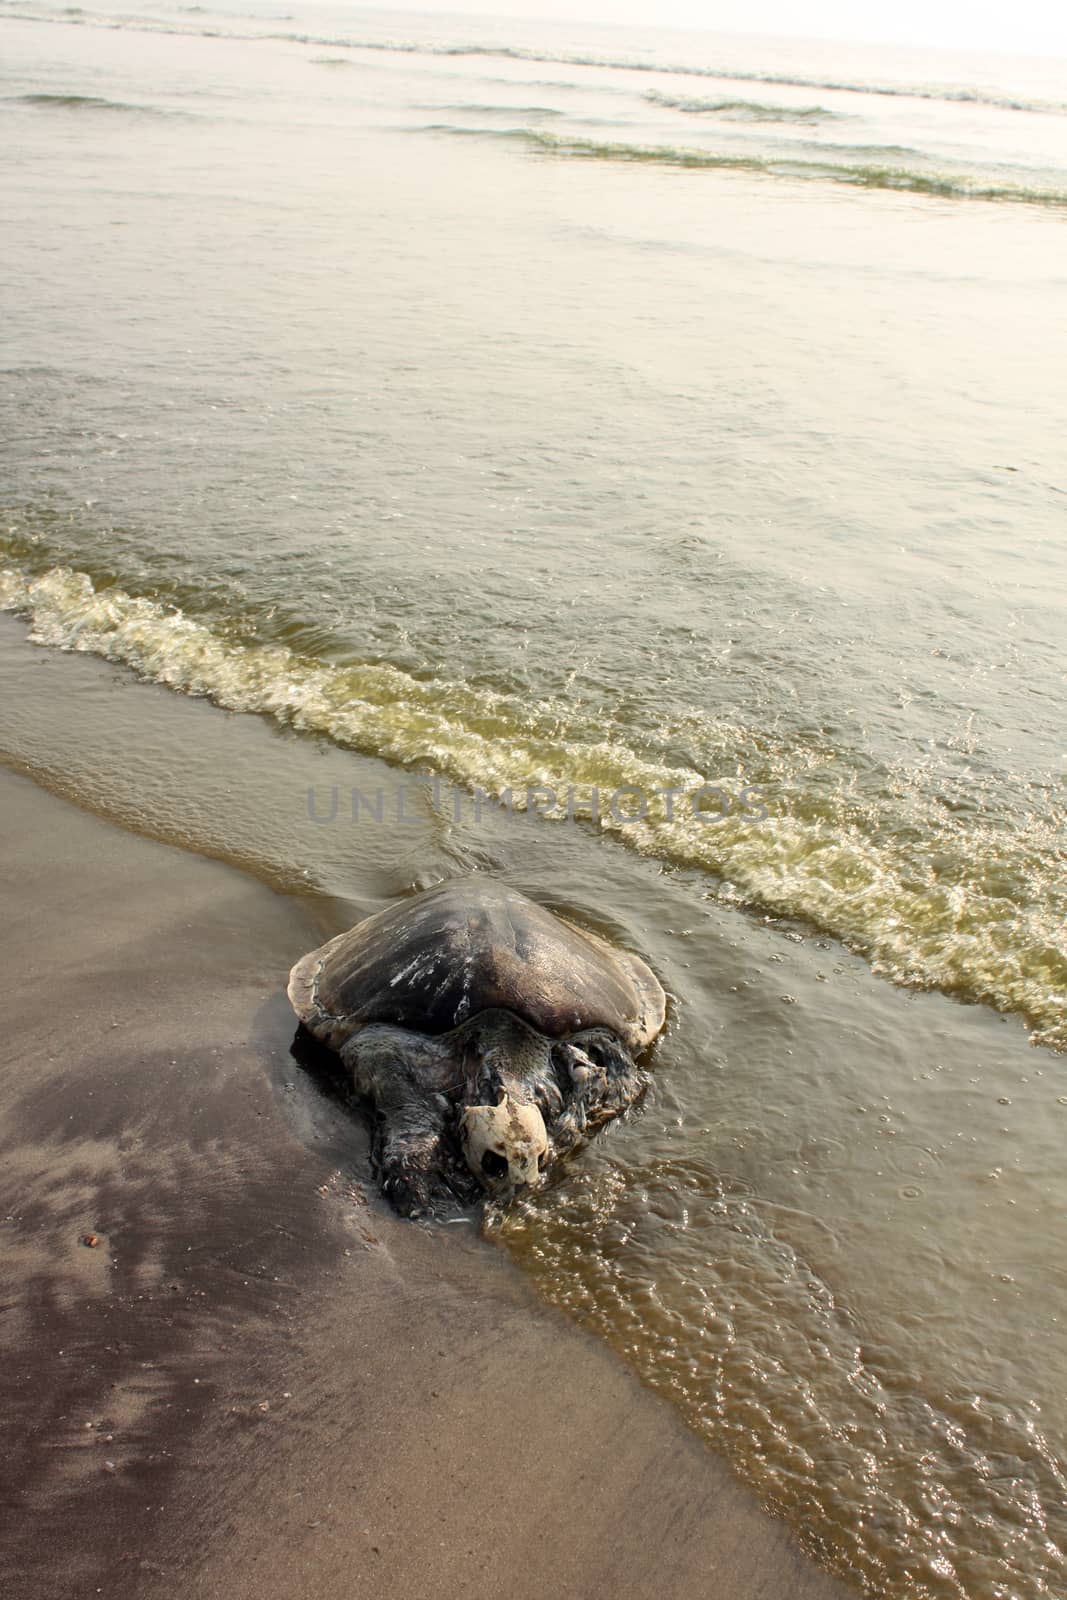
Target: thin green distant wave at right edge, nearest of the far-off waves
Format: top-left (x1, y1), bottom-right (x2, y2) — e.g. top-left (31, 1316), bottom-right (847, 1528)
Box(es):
top-left (447, 123), bottom-right (1067, 208)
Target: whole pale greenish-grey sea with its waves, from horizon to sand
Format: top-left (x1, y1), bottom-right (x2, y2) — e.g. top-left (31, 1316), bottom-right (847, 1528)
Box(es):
top-left (0, 5), bottom-right (1067, 1600)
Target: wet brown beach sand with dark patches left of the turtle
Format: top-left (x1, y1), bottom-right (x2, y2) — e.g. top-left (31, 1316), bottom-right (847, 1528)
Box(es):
top-left (0, 771), bottom-right (848, 1600)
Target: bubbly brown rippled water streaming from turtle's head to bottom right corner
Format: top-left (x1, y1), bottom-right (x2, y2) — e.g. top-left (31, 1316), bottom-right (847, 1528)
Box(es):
top-left (491, 1150), bottom-right (1067, 1600)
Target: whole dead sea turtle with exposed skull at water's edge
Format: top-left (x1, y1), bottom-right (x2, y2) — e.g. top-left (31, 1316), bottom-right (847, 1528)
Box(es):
top-left (290, 878), bottom-right (664, 1216)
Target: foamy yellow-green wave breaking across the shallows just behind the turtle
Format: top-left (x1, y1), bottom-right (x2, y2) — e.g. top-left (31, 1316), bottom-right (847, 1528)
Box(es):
top-left (0, 560), bottom-right (1067, 1050)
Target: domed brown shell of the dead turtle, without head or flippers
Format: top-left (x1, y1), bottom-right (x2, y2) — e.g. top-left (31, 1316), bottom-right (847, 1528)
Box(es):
top-left (290, 878), bottom-right (665, 1050)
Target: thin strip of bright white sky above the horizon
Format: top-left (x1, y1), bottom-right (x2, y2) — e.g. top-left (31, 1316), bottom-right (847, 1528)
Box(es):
top-left (371, 0), bottom-right (1067, 56)
